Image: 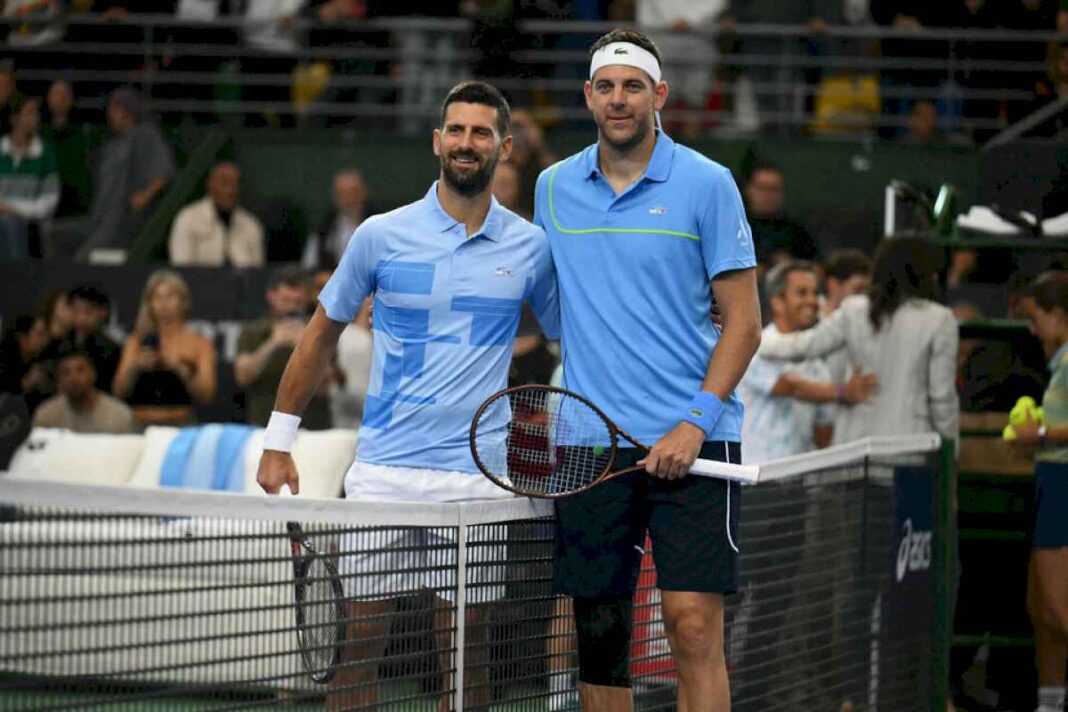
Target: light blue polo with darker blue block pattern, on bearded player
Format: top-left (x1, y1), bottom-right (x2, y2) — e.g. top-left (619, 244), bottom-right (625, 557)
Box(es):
top-left (319, 183), bottom-right (560, 473)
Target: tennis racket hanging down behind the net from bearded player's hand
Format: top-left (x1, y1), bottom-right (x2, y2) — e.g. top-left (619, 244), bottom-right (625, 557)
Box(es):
top-left (285, 522), bottom-right (345, 684)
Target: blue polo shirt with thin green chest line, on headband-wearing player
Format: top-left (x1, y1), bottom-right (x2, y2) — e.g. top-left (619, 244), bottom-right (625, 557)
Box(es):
top-left (534, 132), bottom-right (756, 444)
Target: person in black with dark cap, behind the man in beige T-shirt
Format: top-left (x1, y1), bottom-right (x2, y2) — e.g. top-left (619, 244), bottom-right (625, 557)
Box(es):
top-left (42, 284), bottom-right (122, 390)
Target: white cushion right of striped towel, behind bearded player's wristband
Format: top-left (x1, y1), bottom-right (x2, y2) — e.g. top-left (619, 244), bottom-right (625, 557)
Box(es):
top-left (245, 428), bottom-right (357, 499)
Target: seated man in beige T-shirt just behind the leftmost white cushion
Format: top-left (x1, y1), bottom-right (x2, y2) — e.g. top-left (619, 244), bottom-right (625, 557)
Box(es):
top-left (33, 349), bottom-right (134, 432)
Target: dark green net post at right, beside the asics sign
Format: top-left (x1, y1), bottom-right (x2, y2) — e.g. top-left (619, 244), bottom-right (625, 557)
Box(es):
top-left (931, 438), bottom-right (957, 712)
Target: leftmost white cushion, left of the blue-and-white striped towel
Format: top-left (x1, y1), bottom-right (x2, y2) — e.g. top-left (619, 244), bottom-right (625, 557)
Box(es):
top-left (11, 429), bottom-right (143, 485)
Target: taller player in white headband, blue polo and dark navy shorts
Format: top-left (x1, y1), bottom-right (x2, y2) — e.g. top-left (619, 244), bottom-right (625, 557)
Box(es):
top-left (535, 30), bottom-right (760, 712)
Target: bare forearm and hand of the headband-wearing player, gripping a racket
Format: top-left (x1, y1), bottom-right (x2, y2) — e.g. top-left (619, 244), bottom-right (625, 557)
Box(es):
top-left (644, 269), bottom-right (761, 479)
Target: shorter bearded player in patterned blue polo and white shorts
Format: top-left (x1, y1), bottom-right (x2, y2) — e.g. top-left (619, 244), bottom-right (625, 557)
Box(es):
top-left (257, 82), bottom-right (559, 709)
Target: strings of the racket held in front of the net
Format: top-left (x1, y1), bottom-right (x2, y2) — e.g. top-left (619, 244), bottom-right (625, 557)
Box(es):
top-left (475, 387), bottom-right (612, 495)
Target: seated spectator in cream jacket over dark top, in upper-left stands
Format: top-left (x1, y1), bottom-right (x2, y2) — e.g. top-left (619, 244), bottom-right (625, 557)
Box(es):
top-left (168, 161), bottom-right (266, 267)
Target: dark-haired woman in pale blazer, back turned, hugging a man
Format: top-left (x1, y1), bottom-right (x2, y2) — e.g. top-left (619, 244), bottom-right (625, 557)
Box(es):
top-left (759, 237), bottom-right (960, 443)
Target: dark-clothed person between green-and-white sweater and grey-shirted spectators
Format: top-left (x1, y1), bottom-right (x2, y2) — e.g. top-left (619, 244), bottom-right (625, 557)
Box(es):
top-left (41, 79), bottom-right (92, 218)
